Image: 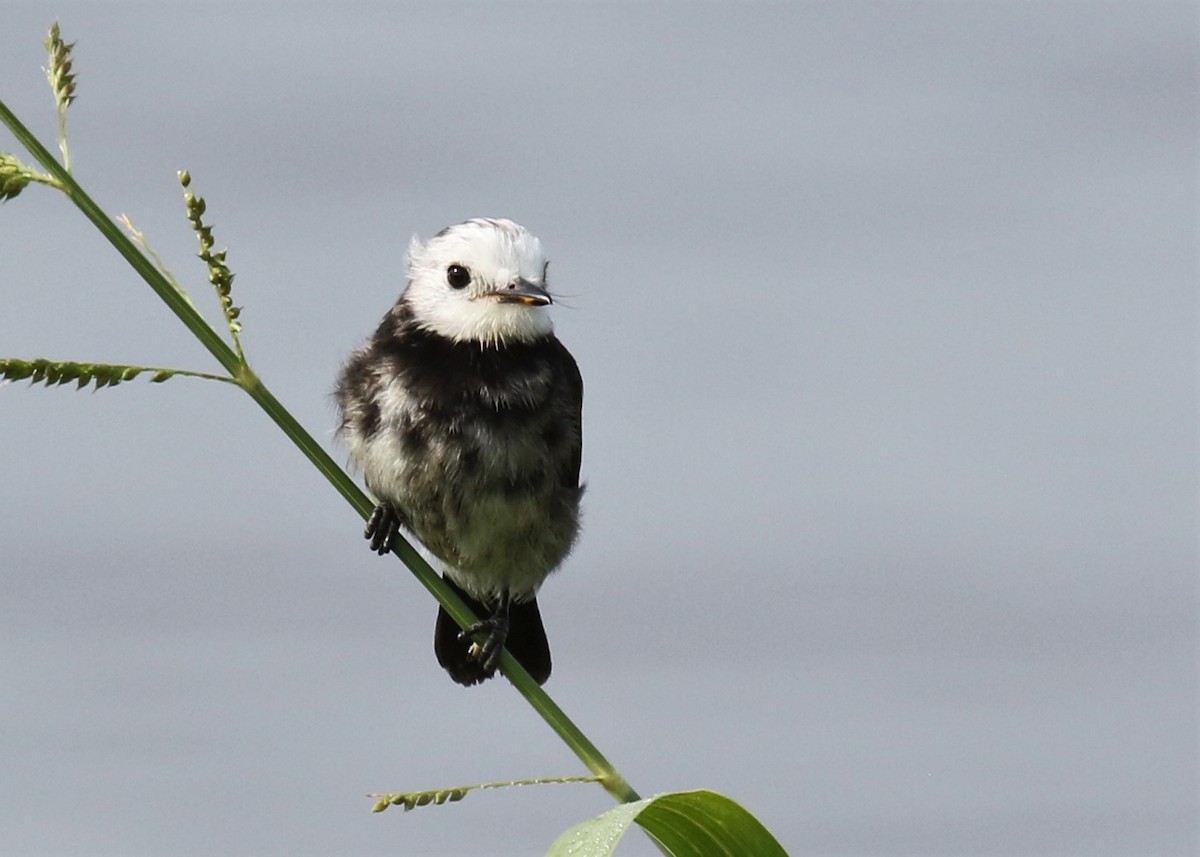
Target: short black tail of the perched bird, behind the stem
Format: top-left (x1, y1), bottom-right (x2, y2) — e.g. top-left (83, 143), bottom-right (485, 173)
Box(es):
top-left (433, 576), bottom-right (551, 687)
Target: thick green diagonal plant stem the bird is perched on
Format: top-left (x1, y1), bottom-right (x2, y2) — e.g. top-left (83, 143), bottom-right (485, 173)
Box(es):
top-left (0, 101), bottom-right (640, 803)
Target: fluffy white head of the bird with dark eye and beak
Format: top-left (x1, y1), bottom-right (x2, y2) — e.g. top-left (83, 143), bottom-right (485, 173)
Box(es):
top-left (401, 217), bottom-right (553, 346)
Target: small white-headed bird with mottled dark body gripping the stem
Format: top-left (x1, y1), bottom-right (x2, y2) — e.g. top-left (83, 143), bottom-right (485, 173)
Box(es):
top-left (335, 217), bottom-right (584, 687)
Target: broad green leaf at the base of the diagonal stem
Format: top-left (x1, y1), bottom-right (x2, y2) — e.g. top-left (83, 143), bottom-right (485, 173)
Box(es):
top-left (546, 789), bottom-right (787, 857)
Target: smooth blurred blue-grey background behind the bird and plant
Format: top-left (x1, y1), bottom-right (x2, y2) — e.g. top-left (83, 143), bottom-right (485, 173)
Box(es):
top-left (0, 2), bottom-right (1198, 855)
